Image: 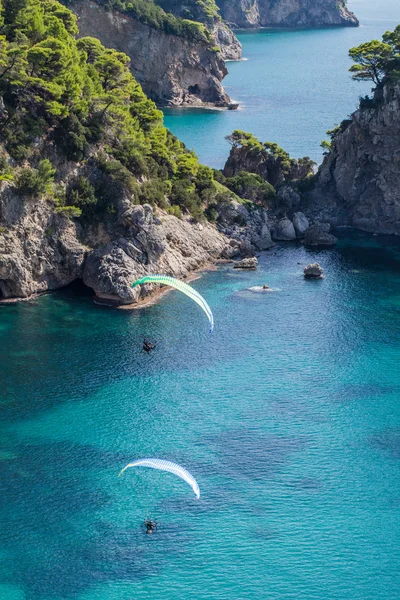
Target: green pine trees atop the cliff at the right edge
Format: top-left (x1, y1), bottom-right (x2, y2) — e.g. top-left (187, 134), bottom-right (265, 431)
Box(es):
top-left (349, 25), bottom-right (400, 86)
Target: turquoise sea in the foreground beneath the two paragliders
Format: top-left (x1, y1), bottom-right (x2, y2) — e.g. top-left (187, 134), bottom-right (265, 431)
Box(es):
top-left (0, 234), bottom-right (400, 600)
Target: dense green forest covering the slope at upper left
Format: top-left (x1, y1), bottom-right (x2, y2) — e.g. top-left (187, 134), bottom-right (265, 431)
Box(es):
top-left (0, 0), bottom-right (225, 218)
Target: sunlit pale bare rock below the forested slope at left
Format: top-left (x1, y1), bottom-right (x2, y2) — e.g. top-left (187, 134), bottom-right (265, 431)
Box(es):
top-left (0, 183), bottom-right (238, 304)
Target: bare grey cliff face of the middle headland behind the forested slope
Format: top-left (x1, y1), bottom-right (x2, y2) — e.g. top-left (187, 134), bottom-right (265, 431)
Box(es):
top-left (71, 0), bottom-right (230, 107)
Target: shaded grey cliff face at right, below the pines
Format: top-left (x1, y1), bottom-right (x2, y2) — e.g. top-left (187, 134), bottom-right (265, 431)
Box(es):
top-left (307, 83), bottom-right (400, 235)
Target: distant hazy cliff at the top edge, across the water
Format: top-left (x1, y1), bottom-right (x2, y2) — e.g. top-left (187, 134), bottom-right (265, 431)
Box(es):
top-left (217, 0), bottom-right (358, 27)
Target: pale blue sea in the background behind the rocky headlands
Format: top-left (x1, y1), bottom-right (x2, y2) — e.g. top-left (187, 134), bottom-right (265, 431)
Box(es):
top-left (165, 0), bottom-right (400, 168)
